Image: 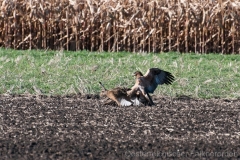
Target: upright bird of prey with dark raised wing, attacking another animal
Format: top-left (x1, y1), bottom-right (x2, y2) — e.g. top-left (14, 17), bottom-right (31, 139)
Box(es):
top-left (129, 68), bottom-right (174, 105)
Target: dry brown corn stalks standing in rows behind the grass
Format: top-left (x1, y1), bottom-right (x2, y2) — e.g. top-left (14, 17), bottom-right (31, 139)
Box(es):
top-left (0, 0), bottom-right (240, 54)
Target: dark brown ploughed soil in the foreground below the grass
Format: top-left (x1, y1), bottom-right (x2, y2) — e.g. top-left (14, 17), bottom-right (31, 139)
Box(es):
top-left (0, 95), bottom-right (240, 160)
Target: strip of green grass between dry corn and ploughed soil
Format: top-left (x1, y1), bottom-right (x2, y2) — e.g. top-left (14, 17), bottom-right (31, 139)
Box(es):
top-left (0, 48), bottom-right (240, 98)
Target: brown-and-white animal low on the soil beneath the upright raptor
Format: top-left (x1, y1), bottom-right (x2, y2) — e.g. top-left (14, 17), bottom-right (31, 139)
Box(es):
top-left (99, 82), bottom-right (149, 106)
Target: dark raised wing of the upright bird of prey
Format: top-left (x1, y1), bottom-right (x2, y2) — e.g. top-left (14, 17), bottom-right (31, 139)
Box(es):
top-left (143, 68), bottom-right (174, 93)
